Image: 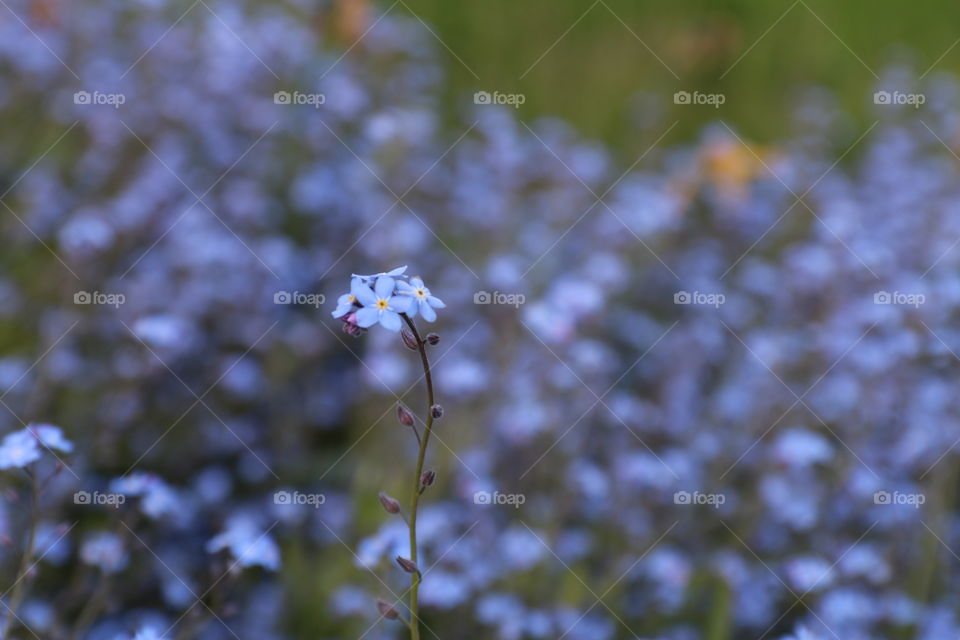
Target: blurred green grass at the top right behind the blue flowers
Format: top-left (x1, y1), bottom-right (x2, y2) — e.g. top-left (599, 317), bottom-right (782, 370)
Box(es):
top-left (396, 0), bottom-right (960, 150)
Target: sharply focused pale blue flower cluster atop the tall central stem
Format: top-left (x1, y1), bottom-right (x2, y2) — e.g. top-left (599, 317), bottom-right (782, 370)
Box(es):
top-left (332, 266), bottom-right (447, 335)
